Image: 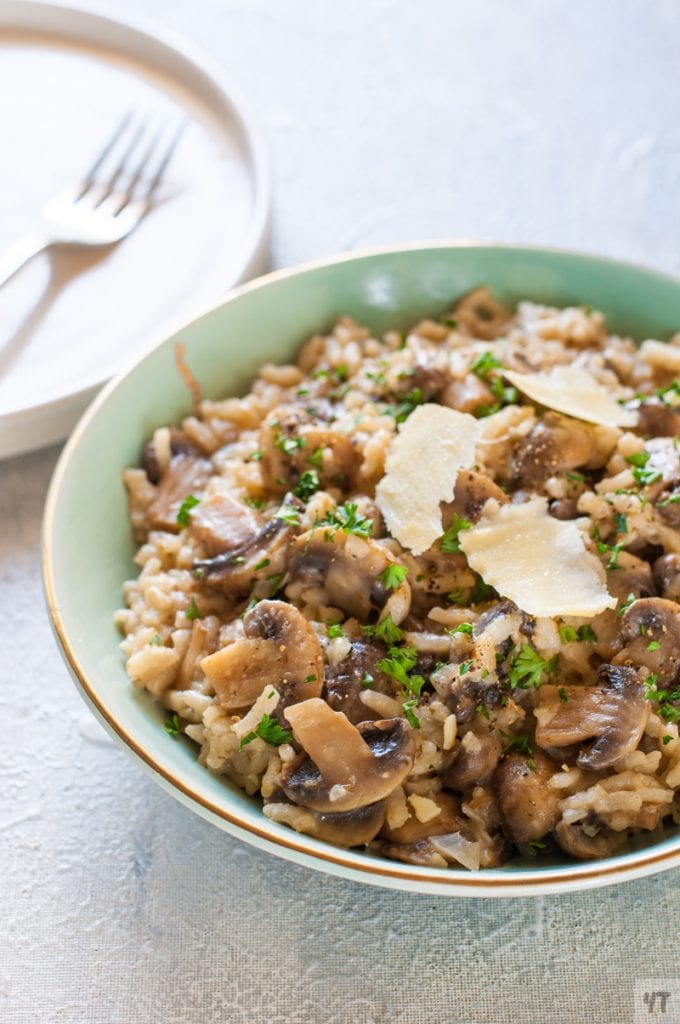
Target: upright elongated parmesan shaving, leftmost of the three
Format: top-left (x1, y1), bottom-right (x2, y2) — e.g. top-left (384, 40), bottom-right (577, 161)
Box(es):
top-left (376, 403), bottom-right (481, 555)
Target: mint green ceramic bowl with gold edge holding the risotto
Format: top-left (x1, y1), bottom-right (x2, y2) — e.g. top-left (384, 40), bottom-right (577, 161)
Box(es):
top-left (44, 244), bottom-right (680, 896)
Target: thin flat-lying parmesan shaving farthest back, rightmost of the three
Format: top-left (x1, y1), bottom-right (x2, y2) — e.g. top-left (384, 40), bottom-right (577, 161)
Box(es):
top-left (503, 367), bottom-right (637, 427)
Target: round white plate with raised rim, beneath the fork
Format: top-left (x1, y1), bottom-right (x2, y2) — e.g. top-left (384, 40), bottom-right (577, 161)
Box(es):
top-left (0, 0), bottom-right (270, 458)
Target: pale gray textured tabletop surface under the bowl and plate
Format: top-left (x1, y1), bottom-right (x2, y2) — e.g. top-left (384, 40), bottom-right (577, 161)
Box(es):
top-left (0, 0), bottom-right (680, 1024)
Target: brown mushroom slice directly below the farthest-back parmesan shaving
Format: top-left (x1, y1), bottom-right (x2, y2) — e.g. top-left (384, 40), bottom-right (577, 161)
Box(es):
top-left (514, 413), bottom-right (595, 488)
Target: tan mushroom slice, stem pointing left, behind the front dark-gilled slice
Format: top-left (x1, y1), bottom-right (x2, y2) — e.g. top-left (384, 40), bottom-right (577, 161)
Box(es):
top-left (201, 601), bottom-right (324, 711)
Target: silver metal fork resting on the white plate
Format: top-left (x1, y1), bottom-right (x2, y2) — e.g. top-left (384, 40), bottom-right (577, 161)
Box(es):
top-left (0, 112), bottom-right (187, 288)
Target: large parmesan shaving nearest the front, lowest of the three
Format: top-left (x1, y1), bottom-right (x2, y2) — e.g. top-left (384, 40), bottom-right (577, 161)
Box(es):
top-left (459, 497), bottom-right (617, 617)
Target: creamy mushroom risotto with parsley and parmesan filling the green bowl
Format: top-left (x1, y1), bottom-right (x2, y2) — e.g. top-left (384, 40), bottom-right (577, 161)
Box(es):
top-left (117, 289), bottom-right (680, 869)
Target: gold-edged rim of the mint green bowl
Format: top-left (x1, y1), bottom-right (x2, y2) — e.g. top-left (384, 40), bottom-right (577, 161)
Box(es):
top-left (41, 239), bottom-right (680, 896)
